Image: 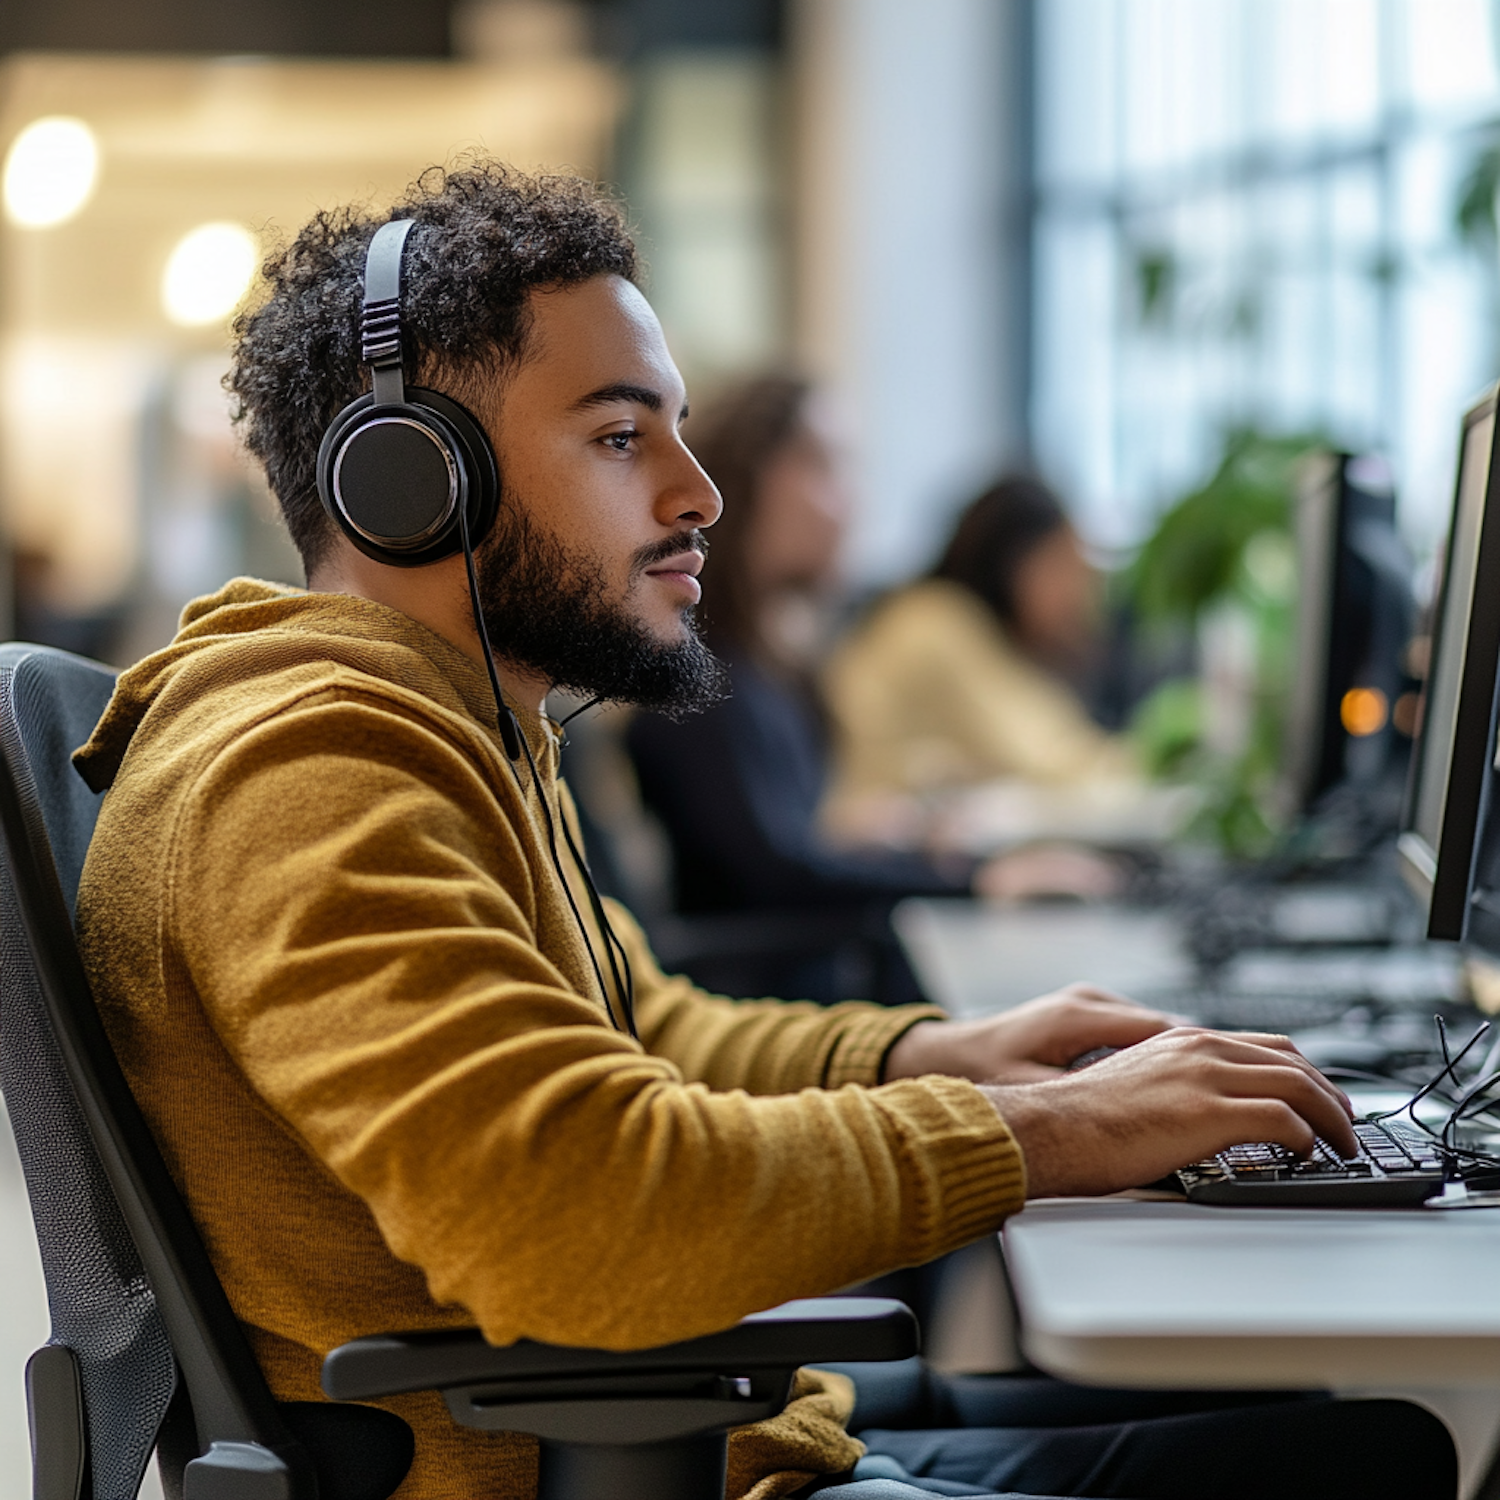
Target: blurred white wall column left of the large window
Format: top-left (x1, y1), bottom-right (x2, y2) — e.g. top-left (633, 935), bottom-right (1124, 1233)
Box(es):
top-left (792, 0), bottom-right (1023, 582)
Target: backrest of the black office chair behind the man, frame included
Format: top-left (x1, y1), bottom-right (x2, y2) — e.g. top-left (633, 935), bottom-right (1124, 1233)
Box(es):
top-left (0, 645), bottom-right (308, 1500)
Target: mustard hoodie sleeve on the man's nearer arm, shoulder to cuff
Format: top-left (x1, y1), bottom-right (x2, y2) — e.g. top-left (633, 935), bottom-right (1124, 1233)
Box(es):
top-left (165, 693), bottom-right (1025, 1349)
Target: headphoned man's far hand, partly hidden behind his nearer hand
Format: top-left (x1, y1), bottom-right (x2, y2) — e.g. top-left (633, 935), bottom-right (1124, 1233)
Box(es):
top-left (885, 984), bottom-right (1176, 1083)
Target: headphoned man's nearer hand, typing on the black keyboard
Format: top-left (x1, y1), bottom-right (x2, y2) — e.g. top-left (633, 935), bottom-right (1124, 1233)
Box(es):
top-left (984, 1026), bottom-right (1356, 1199)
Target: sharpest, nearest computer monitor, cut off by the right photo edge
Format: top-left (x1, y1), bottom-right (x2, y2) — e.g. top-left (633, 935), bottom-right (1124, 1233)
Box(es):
top-left (1398, 387), bottom-right (1500, 942)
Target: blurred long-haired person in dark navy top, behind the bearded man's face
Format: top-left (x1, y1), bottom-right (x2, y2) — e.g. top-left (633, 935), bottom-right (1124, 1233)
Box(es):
top-left (627, 375), bottom-right (1104, 1004)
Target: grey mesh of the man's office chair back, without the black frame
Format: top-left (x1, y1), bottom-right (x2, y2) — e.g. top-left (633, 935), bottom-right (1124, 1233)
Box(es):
top-left (0, 645), bottom-right (177, 1500)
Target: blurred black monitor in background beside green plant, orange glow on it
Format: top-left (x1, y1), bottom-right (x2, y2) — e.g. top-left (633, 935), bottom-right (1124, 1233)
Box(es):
top-left (1283, 453), bottom-right (1416, 831)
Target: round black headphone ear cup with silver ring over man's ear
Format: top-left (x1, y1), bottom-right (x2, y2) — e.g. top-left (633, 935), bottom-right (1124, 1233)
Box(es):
top-left (317, 389), bottom-right (500, 567)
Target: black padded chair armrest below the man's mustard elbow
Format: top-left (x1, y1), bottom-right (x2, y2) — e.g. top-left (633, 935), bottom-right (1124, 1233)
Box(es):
top-left (323, 1298), bottom-right (920, 1401)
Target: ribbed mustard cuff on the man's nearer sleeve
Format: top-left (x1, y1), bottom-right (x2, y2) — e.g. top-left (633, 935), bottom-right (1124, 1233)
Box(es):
top-left (873, 1077), bottom-right (1026, 1265)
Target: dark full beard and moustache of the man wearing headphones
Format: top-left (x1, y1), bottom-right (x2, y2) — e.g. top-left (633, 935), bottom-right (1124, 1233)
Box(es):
top-left (474, 503), bottom-right (729, 719)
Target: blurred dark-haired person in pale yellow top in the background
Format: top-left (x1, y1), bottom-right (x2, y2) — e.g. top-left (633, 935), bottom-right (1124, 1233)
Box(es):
top-left (825, 477), bottom-right (1139, 836)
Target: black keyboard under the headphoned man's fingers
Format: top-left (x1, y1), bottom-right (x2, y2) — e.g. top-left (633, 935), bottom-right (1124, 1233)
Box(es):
top-left (1178, 1122), bottom-right (1443, 1209)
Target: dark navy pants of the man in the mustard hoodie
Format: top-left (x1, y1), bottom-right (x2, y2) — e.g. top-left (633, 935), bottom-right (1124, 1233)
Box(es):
top-left (818, 1359), bottom-right (1458, 1500)
